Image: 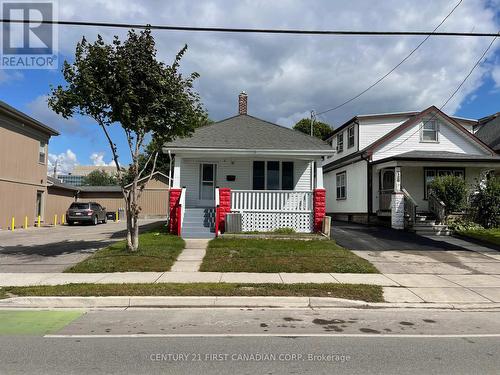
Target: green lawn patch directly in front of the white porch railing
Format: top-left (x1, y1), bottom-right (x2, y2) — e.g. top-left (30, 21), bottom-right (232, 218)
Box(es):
top-left (200, 238), bottom-right (378, 273)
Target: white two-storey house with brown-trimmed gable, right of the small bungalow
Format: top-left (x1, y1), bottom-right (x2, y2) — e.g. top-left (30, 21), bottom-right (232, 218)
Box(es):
top-left (323, 106), bottom-right (500, 233)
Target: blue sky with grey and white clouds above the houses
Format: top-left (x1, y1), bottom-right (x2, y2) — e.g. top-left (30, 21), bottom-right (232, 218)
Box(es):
top-left (0, 0), bottom-right (500, 171)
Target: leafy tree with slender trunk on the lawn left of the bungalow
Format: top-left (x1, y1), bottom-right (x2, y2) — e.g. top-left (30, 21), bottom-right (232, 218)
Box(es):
top-left (49, 29), bottom-right (207, 251)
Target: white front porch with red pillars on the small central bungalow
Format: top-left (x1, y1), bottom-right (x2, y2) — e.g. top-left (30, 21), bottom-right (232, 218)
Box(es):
top-left (172, 152), bottom-right (325, 235)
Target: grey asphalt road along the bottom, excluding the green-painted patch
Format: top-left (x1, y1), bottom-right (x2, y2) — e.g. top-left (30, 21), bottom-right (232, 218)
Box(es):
top-left (0, 309), bottom-right (500, 375)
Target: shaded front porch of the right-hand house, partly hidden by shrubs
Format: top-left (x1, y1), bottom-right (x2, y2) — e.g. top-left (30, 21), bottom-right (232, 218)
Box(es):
top-left (370, 156), bottom-right (500, 229)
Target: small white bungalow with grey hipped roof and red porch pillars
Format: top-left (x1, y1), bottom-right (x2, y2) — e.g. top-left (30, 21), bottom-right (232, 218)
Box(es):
top-left (163, 93), bottom-right (335, 238)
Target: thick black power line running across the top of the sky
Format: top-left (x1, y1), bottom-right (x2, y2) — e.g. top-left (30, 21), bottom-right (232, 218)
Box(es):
top-left (0, 18), bottom-right (498, 37)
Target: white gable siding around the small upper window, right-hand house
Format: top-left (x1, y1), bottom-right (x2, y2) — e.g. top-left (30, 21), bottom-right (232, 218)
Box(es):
top-left (373, 115), bottom-right (487, 161)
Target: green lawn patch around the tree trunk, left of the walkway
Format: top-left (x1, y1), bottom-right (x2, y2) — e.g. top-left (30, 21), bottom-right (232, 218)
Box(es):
top-left (64, 226), bottom-right (185, 273)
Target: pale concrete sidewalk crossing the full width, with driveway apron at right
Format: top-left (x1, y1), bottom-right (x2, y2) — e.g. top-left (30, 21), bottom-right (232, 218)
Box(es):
top-left (0, 272), bottom-right (500, 303)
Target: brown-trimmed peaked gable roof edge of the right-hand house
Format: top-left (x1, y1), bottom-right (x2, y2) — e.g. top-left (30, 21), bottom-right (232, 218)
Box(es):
top-left (365, 106), bottom-right (495, 156)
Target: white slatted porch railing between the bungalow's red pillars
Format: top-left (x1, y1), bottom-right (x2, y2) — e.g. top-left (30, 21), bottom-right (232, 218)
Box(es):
top-left (231, 190), bottom-right (313, 213)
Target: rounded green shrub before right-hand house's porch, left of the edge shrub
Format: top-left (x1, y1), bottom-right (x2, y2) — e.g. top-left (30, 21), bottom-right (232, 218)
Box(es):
top-left (430, 176), bottom-right (467, 214)
